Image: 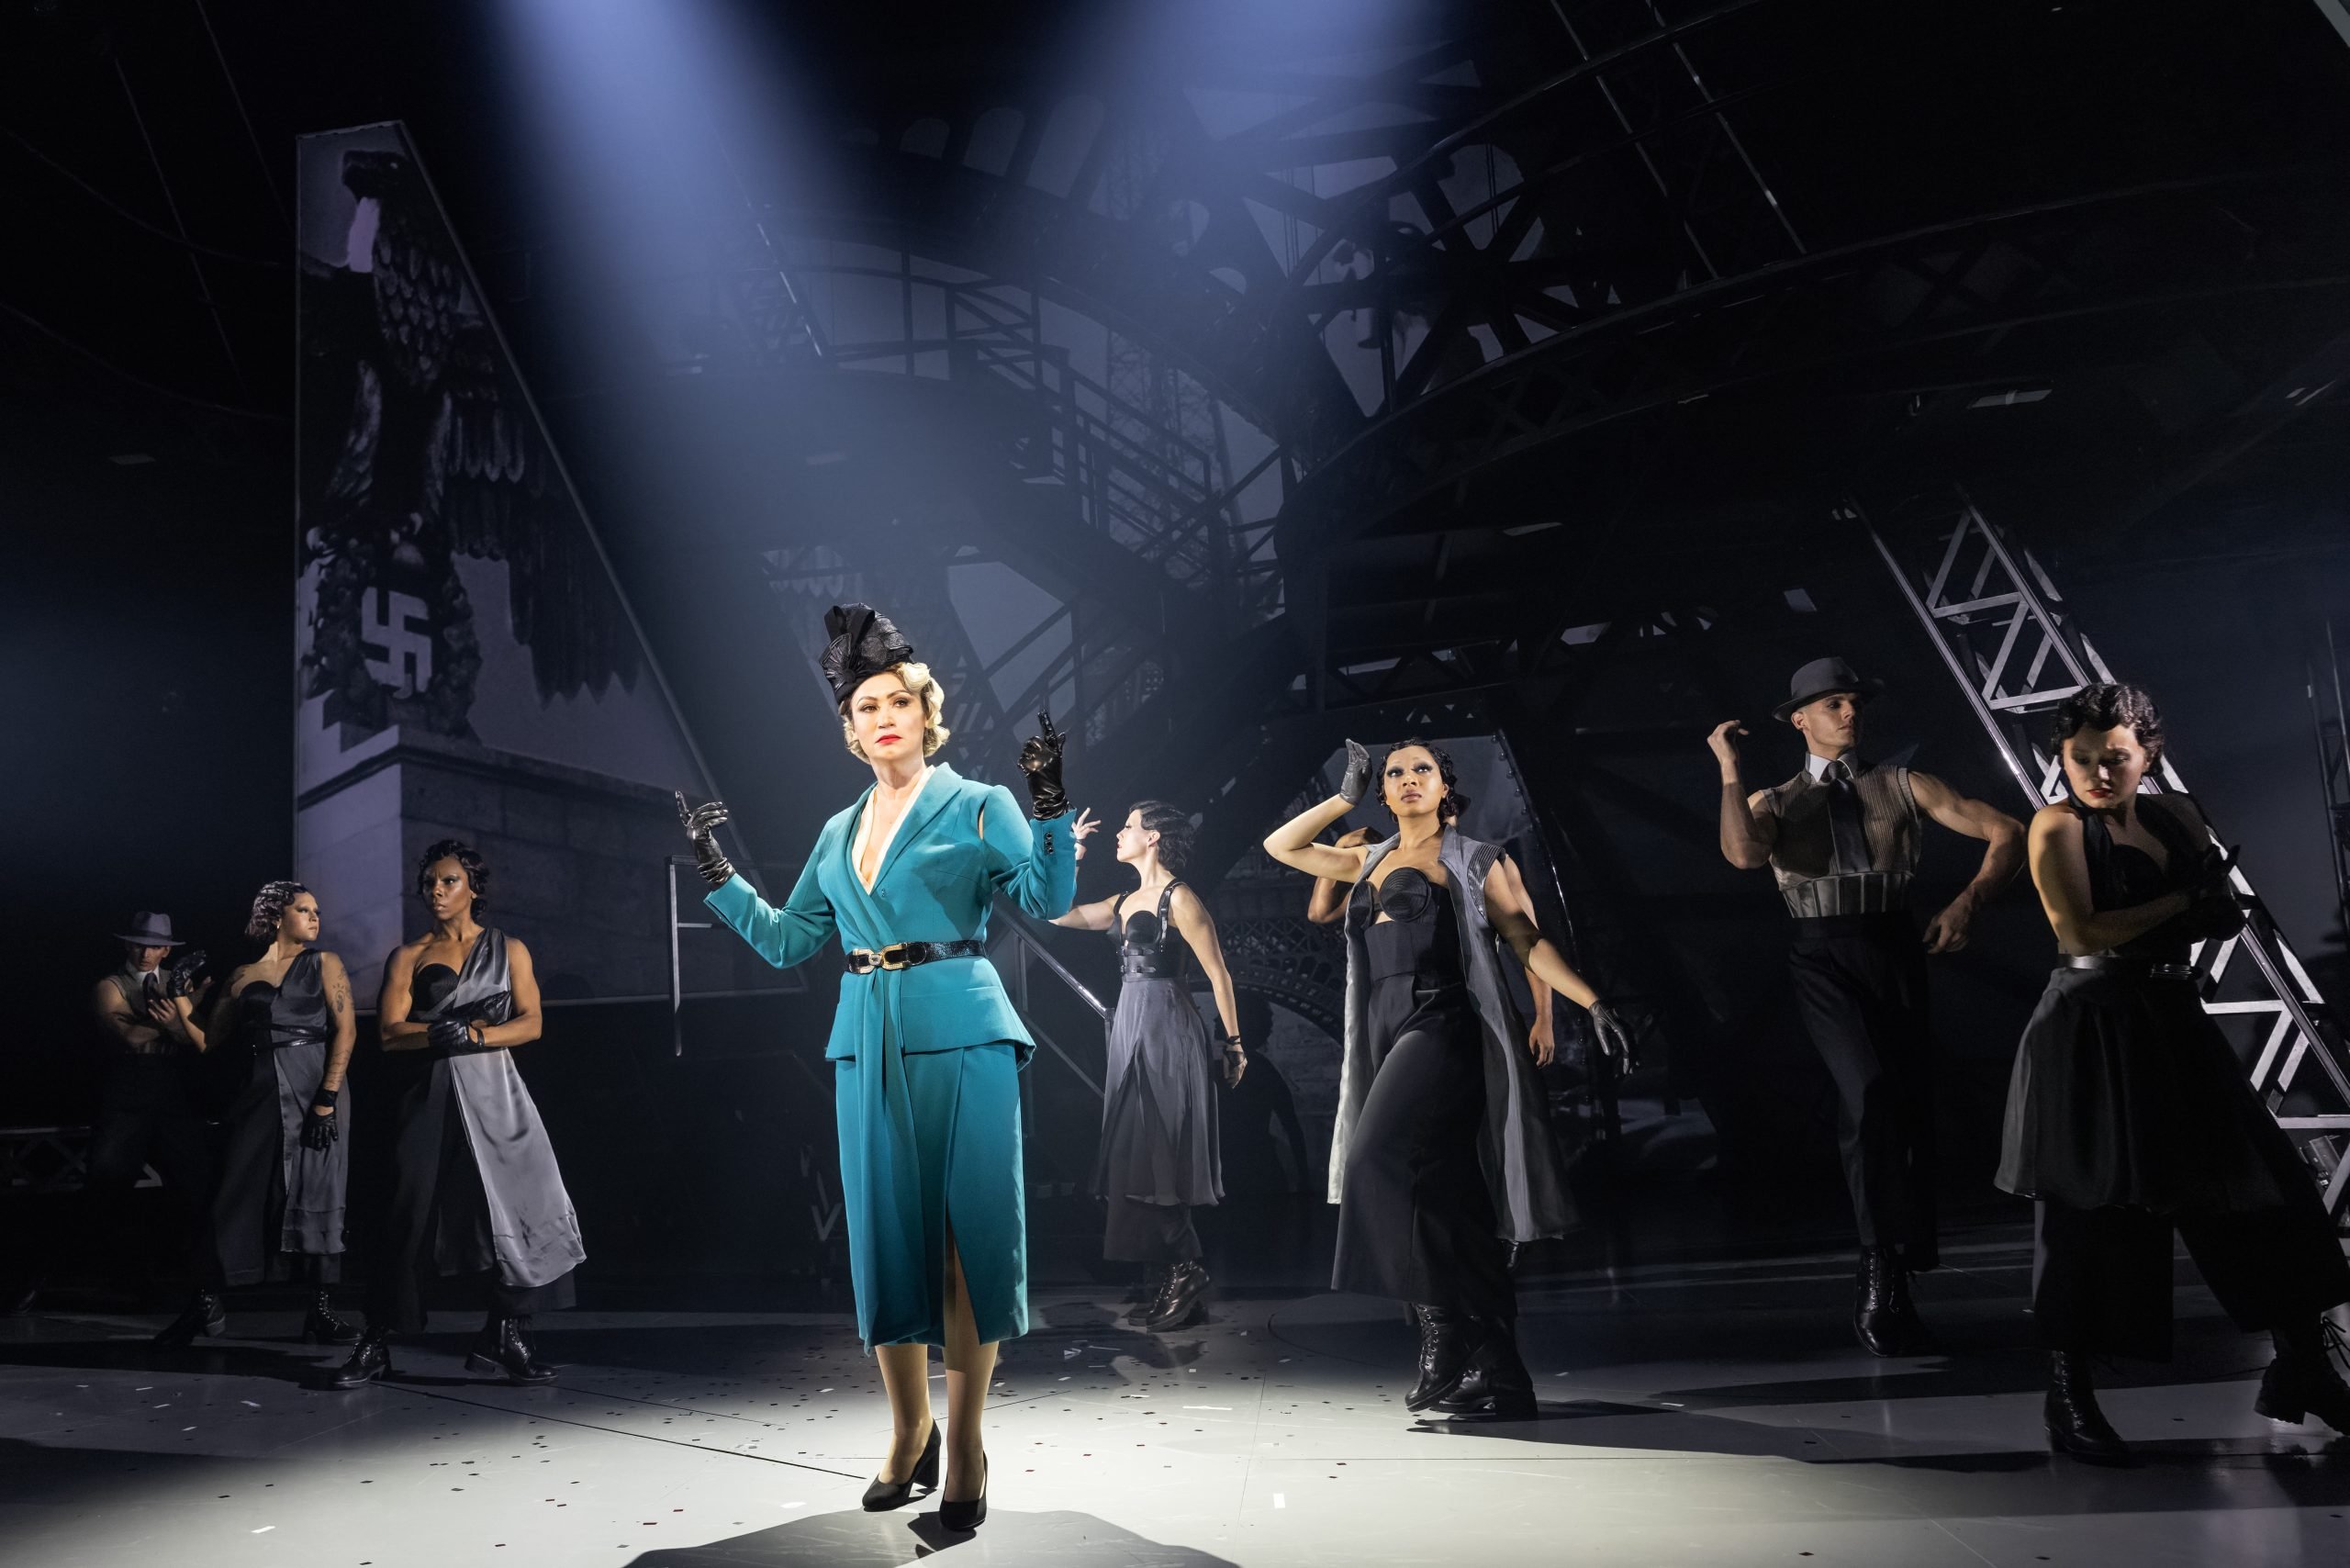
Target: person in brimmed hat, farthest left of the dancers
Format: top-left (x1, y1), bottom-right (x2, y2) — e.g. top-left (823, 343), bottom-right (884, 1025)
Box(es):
top-left (83, 910), bottom-right (226, 1345)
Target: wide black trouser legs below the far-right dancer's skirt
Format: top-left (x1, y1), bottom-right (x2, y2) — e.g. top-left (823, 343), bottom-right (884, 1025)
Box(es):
top-left (2032, 1202), bottom-right (2350, 1361)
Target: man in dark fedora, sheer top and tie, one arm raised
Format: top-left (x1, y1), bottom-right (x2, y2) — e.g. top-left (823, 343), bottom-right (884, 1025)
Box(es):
top-left (1707, 658), bottom-right (2023, 1357)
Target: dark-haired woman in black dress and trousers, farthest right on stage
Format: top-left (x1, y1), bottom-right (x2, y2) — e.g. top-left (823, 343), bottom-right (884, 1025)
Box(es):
top-left (1995, 684), bottom-right (2350, 1460)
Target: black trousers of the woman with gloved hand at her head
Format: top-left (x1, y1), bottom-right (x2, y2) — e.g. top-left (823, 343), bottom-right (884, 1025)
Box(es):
top-left (1330, 1014), bottom-right (1518, 1321)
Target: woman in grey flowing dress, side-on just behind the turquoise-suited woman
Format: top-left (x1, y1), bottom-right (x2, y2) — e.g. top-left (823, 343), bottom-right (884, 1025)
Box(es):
top-left (1053, 800), bottom-right (1248, 1333)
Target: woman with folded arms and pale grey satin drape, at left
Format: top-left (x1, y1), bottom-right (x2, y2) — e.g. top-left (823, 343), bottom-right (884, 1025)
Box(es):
top-left (334, 839), bottom-right (588, 1387)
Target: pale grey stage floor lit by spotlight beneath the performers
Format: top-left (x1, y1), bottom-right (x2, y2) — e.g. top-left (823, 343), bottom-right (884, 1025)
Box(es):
top-left (0, 1227), bottom-right (2350, 1568)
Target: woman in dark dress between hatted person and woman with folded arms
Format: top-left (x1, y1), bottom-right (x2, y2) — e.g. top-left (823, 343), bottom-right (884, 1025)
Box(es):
top-left (158, 881), bottom-right (360, 1345)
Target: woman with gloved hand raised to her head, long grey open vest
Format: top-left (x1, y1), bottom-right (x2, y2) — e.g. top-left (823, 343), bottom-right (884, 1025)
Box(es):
top-left (1264, 741), bottom-right (1628, 1420)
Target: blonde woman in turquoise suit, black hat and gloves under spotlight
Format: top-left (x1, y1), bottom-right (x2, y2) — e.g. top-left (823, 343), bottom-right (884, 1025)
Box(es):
top-left (677, 604), bottom-right (1076, 1528)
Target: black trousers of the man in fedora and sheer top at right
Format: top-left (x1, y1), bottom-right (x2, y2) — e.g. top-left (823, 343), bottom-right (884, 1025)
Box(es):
top-left (1788, 913), bottom-right (1942, 1270)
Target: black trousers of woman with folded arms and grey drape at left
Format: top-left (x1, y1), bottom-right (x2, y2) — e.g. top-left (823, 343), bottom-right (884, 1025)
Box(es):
top-left (366, 1062), bottom-right (574, 1333)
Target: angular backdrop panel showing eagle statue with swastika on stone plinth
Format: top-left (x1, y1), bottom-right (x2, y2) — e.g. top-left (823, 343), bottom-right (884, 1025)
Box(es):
top-left (294, 125), bottom-right (714, 999)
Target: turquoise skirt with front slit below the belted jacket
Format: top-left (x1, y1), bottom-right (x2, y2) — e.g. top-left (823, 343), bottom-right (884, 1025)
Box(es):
top-left (832, 1041), bottom-right (1027, 1345)
